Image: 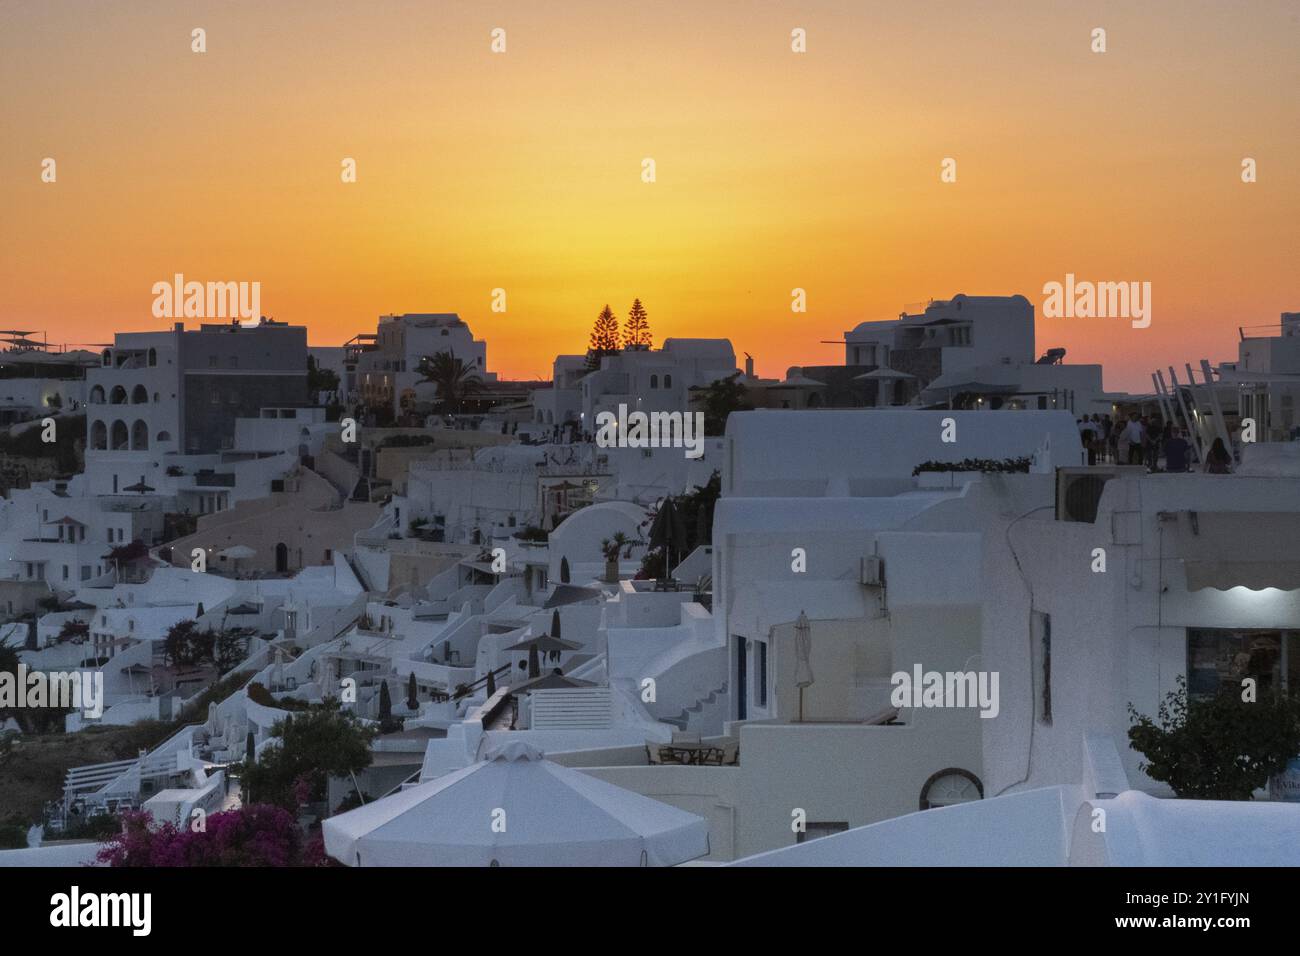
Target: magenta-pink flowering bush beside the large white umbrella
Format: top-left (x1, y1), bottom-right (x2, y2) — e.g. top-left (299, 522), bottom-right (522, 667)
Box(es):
top-left (96, 804), bottom-right (325, 866)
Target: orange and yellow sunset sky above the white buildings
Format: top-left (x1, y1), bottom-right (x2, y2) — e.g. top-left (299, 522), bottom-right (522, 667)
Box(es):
top-left (0, 0), bottom-right (1300, 390)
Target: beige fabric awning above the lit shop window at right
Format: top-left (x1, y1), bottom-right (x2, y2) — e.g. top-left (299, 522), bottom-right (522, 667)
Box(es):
top-left (1178, 511), bottom-right (1300, 591)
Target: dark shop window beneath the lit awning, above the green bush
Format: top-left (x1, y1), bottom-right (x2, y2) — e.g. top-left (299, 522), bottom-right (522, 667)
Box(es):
top-left (1187, 628), bottom-right (1300, 697)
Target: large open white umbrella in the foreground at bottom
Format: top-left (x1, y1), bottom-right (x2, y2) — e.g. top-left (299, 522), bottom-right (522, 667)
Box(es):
top-left (322, 739), bottom-right (709, 866)
